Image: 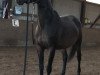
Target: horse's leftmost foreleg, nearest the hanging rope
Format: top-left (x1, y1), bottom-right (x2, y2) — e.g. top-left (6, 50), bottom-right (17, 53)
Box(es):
top-left (38, 48), bottom-right (44, 75)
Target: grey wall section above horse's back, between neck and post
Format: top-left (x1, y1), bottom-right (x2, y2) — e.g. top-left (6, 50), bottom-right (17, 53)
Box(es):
top-left (54, 0), bottom-right (81, 18)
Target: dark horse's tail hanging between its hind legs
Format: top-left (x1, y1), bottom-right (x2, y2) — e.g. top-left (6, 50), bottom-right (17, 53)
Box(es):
top-left (68, 24), bottom-right (82, 61)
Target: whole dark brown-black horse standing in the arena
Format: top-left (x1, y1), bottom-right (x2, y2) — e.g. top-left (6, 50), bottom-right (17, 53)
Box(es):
top-left (17, 0), bottom-right (82, 75)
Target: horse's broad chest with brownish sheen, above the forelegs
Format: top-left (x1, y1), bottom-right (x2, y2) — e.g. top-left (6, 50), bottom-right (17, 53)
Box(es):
top-left (35, 26), bottom-right (57, 47)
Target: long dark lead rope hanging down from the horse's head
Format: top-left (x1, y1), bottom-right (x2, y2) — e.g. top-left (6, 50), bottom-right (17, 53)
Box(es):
top-left (23, 3), bottom-right (29, 75)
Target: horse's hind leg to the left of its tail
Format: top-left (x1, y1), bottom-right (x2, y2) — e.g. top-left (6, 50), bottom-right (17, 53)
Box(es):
top-left (61, 49), bottom-right (68, 75)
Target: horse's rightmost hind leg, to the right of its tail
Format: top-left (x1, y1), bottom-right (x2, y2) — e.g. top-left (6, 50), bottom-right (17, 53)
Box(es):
top-left (77, 35), bottom-right (82, 75)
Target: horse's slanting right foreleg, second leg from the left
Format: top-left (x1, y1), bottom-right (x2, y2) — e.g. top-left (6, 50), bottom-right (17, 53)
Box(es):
top-left (47, 48), bottom-right (55, 75)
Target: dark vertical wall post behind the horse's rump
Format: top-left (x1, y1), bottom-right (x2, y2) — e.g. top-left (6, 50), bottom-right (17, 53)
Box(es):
top-left (80, 0), bottom-right (86, 25)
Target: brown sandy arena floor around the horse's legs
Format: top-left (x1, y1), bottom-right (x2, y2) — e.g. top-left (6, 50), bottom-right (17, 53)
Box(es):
top-left (0, 47), bottom-right (100, 75)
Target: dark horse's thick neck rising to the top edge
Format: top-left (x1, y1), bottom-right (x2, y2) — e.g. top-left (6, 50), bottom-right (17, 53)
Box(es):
top-left (38, 0), bottom-right (53, 27)
